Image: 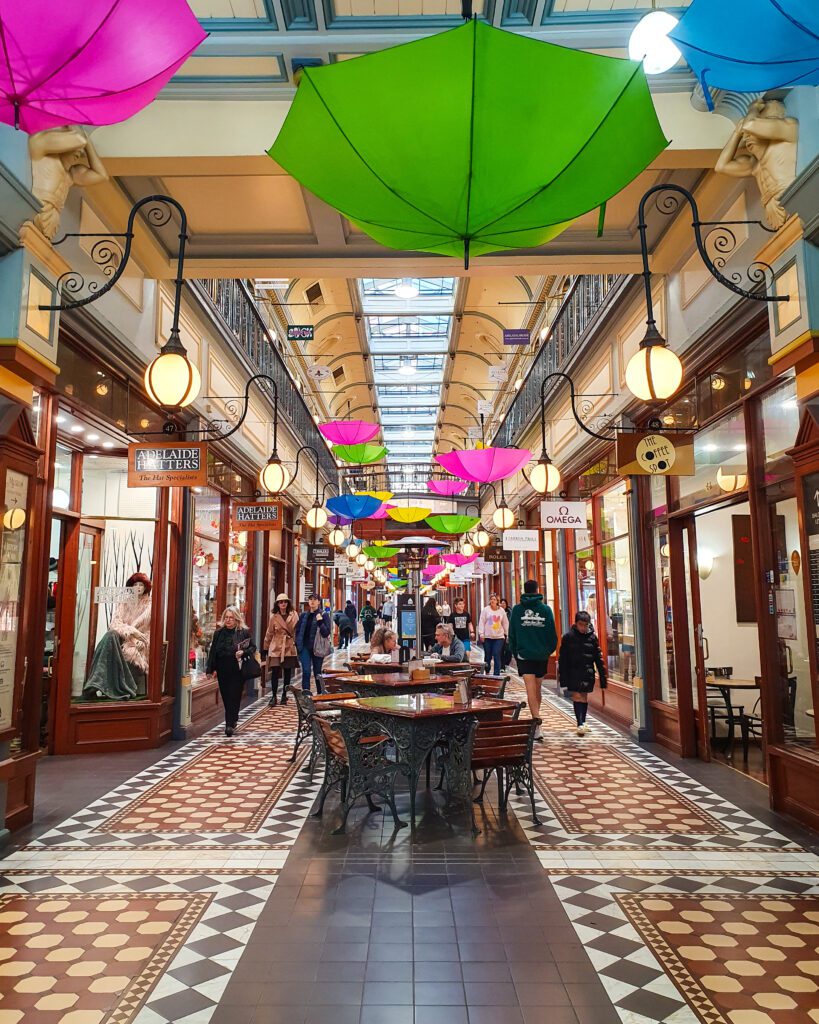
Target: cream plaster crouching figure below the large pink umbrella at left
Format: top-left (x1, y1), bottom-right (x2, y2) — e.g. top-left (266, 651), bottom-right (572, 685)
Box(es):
top-left (29, 125), bottom-right (109, 241)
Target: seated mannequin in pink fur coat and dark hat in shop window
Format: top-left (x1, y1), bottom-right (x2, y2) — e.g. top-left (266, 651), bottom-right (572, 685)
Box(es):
top-left (83, 572), bottom-right (150, 700)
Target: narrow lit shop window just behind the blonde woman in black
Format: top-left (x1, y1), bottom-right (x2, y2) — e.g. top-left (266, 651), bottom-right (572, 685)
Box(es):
top-left (189, 487), bottom-right (223, 683)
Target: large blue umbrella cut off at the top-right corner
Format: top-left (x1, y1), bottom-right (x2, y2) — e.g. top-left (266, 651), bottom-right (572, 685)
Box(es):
top-left (669, 0), bottom-right (819, 105)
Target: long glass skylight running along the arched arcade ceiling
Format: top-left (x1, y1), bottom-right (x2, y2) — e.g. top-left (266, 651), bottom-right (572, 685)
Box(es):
top-left (359, 278), bottom-right (457, 475)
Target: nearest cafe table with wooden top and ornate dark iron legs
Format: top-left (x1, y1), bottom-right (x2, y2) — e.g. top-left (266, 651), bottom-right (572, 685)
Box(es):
top-left (325, 681), bottom-right (517, 828)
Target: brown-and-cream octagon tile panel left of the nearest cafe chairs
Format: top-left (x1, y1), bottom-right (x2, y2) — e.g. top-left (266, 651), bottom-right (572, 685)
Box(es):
top-left (97, 743), bottom-right (307, 834)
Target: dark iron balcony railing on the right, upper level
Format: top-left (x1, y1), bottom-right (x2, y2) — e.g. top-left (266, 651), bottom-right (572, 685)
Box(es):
top-left (492, 274), bottom-right (623, 447)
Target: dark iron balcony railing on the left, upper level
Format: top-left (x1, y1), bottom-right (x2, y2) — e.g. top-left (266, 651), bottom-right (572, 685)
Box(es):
top-left (191, 279), bottom-right (338, 481)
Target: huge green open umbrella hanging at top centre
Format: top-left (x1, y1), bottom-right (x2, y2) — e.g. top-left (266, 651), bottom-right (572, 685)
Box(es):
top-left (269, 19), bottom-right (669, 264)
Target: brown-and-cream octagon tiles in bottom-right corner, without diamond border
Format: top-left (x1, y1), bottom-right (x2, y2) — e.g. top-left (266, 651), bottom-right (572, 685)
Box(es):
top-left (617, 893), bottom-right (819, 1024)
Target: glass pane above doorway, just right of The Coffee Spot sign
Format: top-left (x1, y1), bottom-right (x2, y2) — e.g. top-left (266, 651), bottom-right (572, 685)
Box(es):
top-left (679, 409), bottom-right (747, 508)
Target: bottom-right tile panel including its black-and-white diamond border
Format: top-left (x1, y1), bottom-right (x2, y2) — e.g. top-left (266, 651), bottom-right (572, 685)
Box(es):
top-left (550, 872), bottom-right (819, 1024)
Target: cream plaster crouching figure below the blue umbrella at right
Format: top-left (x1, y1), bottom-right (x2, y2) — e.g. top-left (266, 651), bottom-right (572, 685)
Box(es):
top-left (715, 99), bottom-right (799, 229)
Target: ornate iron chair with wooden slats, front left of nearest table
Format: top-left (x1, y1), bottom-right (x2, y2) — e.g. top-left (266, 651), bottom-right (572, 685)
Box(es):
top-left (313, 715), bottom-right (406, 836)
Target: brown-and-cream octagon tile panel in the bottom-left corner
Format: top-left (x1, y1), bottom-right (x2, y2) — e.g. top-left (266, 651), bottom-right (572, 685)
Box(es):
top-left (0, 893), bottom-right (210, 1024)
